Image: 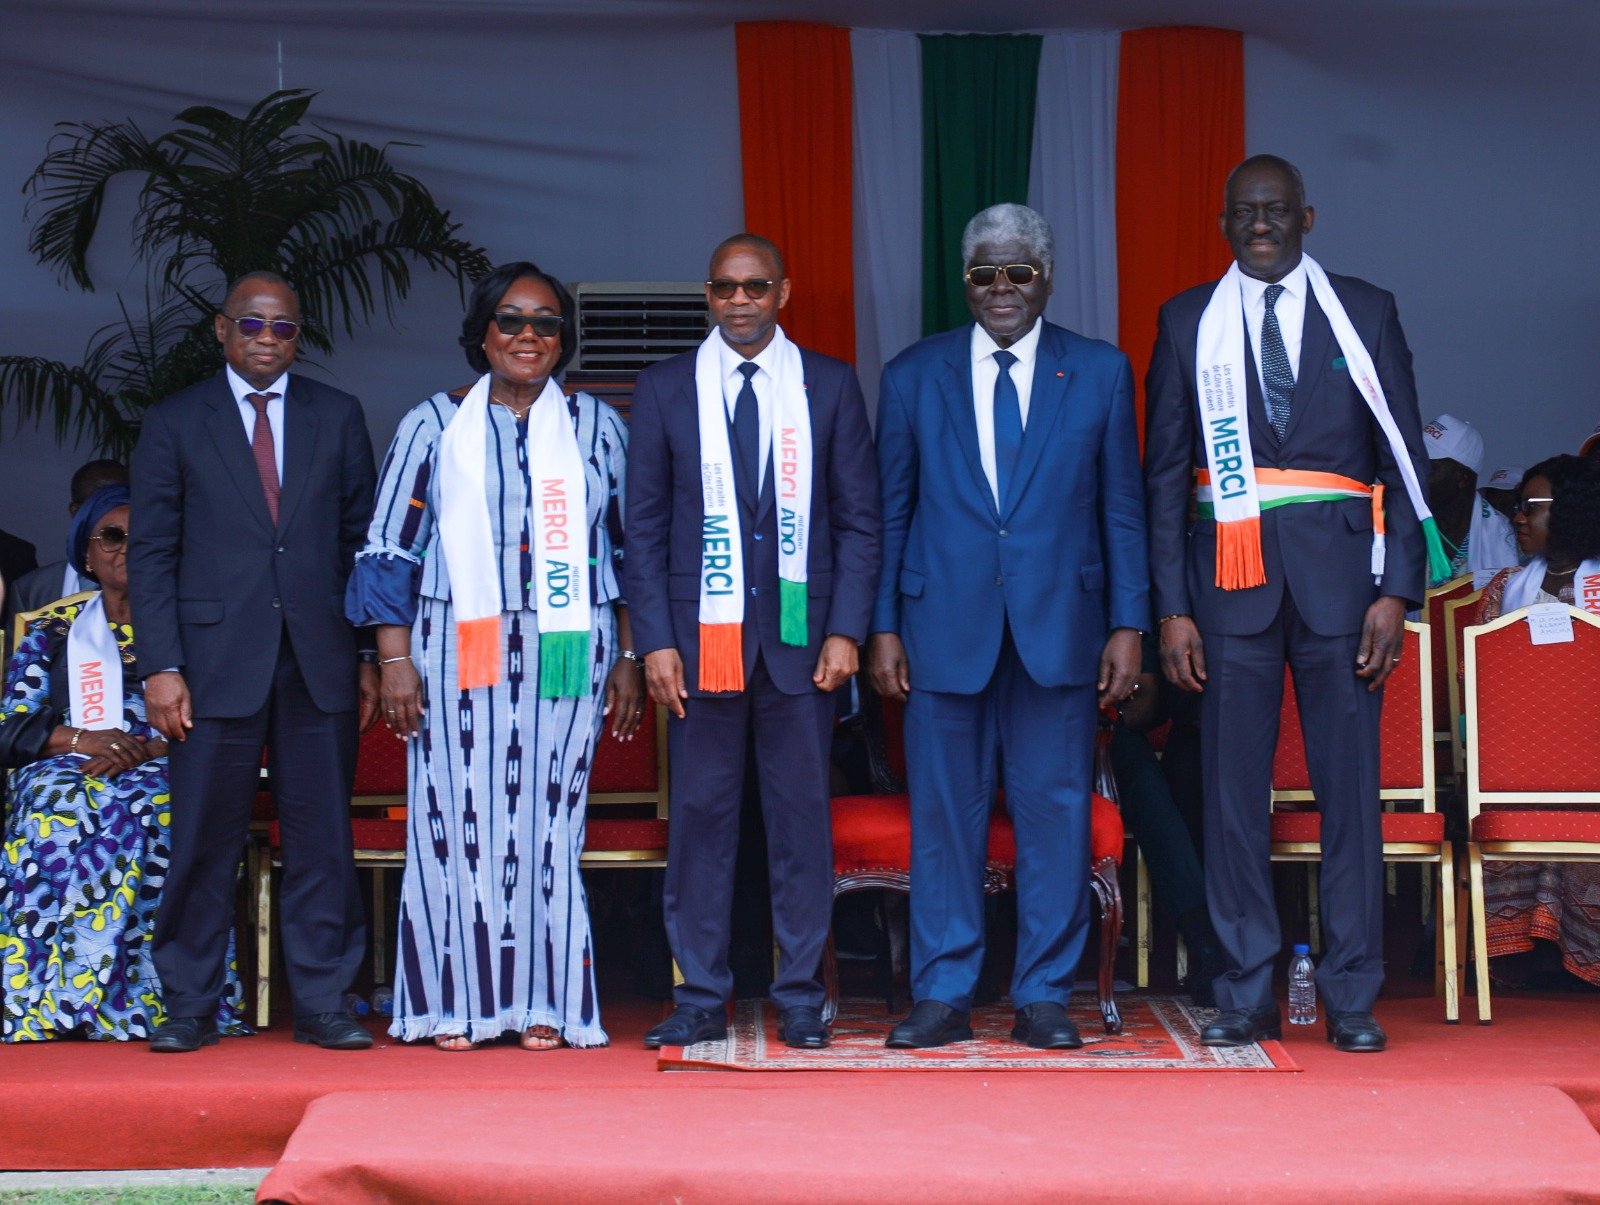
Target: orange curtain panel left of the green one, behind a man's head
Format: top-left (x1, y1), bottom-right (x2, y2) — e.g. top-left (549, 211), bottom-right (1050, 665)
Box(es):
top-left (730, 21), bottom-right (856, 362)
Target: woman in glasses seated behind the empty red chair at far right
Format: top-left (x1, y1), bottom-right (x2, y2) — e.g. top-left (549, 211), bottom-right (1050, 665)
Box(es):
top-left (1477, 456), bottom-right (1600, 987)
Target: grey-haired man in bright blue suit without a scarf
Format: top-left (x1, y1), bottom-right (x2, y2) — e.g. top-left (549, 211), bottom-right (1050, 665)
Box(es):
top-left (867, 205), bottom-right (1150, 1050)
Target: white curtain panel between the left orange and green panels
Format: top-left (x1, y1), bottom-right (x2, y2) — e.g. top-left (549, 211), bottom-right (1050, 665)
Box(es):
top-left (850, 29), bottom-right (928, 419)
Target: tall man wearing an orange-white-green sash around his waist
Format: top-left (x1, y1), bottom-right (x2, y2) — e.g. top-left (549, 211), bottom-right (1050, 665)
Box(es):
top-left (1146, 155), bottom-right (1427, 1051)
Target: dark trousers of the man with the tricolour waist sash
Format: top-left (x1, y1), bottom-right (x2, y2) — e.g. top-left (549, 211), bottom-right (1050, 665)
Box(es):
top-left (1200, 590), bottom-right (1384, 1011)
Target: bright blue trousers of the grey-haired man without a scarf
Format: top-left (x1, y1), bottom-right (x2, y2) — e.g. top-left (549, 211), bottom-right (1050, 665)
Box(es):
top-left (906, 631), bottom-right (1096, 1011)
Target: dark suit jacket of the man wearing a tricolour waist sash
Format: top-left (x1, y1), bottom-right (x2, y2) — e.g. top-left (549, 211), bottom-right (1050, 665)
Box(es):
top-left (1144, 274), bottom-right (1427, 635)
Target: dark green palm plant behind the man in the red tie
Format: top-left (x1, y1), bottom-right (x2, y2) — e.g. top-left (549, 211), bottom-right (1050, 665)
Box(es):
top-left (0, 90), bottom-right (490, 454)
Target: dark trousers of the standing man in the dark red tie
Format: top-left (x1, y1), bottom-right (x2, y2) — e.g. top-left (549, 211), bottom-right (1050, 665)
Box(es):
top-left (154, 634), bottom-right (366, 1016)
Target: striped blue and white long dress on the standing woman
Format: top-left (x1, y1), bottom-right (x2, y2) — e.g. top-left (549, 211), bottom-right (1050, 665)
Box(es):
top-left (346, 394), bottom-right (627, 1047)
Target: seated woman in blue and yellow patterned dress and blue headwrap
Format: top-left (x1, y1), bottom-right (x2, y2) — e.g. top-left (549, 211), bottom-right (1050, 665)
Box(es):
top-left (0, 485), bottom-right (250, 1042)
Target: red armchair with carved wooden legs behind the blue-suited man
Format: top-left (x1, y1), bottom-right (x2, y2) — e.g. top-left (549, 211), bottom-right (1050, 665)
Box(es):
top-left (822, 685), bottom-right (1125, 1034)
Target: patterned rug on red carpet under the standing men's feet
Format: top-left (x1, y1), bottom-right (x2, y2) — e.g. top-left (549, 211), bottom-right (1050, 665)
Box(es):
top-left (656, 995), bottom-right (1299, 1071)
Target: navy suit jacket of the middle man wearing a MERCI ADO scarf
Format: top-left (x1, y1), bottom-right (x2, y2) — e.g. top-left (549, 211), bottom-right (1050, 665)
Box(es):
top-left (624, 339), bottom-right (880, 698)
